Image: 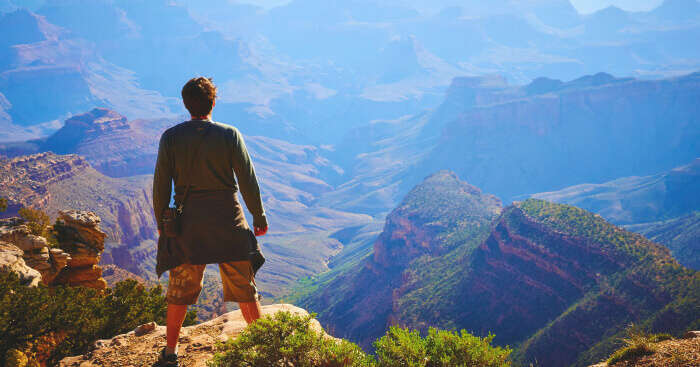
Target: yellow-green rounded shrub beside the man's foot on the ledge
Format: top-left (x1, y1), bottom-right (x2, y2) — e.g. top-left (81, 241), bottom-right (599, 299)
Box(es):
top-left (209, 312), bottom-right (374, 367)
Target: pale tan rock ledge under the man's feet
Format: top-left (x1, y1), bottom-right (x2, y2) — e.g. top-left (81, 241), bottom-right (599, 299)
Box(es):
top-left (59, 304), bottom-right (323, 367)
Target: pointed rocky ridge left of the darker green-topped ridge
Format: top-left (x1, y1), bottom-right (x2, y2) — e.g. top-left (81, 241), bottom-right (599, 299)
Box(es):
top-left (302, 171), bottom-right (501, 347)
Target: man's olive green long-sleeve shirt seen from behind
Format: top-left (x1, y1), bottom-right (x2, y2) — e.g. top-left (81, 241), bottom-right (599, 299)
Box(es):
top-left (153, 120), bottom-right (267, 227)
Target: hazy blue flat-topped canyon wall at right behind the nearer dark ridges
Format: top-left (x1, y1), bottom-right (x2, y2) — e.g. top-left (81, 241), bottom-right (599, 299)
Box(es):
top-left (325, 73), bottom-right (700, 213)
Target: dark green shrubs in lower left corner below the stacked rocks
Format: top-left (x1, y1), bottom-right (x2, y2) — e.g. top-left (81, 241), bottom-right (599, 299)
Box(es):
top-left (0, 273), bottom-right (194, 365)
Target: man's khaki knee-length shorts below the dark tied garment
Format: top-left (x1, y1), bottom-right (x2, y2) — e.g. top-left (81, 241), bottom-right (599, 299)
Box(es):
top-left (166, 261), bottom-right (257, 305)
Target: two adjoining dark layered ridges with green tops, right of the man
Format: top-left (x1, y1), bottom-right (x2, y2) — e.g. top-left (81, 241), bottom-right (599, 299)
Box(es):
top-left (298, 172), bottom-right (700, 366)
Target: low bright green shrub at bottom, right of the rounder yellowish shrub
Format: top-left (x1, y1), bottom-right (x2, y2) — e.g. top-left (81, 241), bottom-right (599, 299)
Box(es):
top-left (374, 327), bottom-right (511, 367)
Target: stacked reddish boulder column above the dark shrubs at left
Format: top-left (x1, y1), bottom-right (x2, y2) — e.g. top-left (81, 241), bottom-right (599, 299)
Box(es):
top-left (54, 210), bottom-right (107, 289)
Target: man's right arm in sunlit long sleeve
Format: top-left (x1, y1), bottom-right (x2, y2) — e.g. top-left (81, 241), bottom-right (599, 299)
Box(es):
top-left (233, 129), bottom-right (267, 235)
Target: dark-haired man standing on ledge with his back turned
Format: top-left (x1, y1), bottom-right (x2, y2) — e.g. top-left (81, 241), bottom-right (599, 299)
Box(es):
top-left (153, 77), bottom-right (267, 367)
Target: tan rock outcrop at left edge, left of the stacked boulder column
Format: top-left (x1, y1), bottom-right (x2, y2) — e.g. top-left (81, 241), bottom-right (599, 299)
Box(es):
top-left (0, 218), bottom-right (70, 285)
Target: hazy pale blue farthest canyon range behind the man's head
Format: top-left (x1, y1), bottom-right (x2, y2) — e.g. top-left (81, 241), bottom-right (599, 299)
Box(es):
top-left (0, 0), bottom-right (700, 145)
